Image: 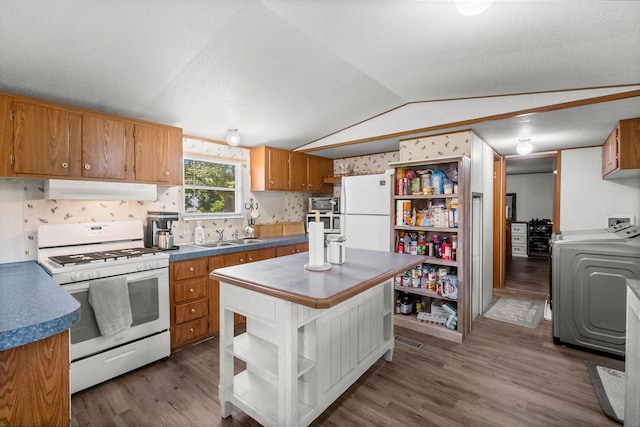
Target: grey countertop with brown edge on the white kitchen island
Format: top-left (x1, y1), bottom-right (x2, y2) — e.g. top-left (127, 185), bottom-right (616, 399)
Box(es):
top-left (211, 248), bottom-right (424, 309)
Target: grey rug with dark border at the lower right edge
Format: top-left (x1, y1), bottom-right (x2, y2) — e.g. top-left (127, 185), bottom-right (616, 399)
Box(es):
top-left (586, 360), bottom-right (626, 424)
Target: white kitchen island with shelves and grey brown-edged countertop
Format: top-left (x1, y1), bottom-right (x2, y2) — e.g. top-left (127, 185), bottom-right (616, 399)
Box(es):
top-left (211, 248), bottom-right (423, 426)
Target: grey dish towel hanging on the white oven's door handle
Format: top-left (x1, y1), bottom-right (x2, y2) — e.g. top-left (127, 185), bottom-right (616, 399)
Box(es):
top-left (89, 276), bottom-right (133, 337)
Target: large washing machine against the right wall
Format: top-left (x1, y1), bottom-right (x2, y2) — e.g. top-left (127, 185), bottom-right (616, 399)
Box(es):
top-left (551, 231), bottom-right (640, 356)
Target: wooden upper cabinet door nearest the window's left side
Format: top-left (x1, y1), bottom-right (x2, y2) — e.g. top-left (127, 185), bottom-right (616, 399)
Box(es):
top-left (134, 123), bottom-right (171, 183)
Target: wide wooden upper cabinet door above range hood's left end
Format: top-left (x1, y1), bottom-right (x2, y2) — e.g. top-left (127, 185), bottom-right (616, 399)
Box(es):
top-left (13, 101), bottom-right (70, 176)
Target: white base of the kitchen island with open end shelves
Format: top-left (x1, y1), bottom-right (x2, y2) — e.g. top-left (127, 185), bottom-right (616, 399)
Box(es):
top-left (219, 280), bottom-right (394, 426)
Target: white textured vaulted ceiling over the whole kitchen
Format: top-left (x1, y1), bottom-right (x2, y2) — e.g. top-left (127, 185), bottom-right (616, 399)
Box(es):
top-left (0, 0), bottom-right (640, 158)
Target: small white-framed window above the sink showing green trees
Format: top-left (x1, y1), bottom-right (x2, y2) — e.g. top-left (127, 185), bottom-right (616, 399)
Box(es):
top-left (184, 156), bottom-right (242, 217)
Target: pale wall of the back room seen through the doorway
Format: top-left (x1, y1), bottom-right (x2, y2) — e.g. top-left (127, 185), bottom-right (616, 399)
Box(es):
top-left (507, 173), bottom-right (553, 222)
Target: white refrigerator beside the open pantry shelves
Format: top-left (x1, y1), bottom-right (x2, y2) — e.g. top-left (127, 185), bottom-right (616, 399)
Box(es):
top-left (340, 169), bottom-right (394, 252)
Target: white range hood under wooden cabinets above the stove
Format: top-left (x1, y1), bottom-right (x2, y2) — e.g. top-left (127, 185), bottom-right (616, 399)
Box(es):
top-left (44, 179), bottom-right (158, 201)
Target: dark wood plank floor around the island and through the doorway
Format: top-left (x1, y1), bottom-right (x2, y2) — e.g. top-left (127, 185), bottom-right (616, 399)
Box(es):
top-left (71, 259), bottom-right (624, 427)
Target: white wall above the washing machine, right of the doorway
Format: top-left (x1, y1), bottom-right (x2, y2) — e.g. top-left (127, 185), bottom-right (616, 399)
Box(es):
top-left (559, 147), bottom-right (640, 230)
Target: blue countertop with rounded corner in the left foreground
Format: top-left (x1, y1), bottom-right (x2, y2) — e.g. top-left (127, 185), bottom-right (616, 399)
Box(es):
top-left (0, 261), bottom-right (80, 351)
